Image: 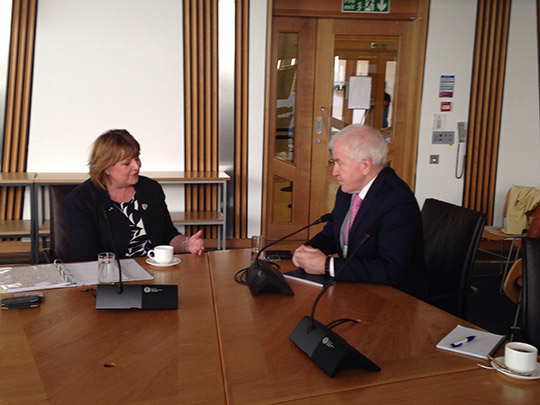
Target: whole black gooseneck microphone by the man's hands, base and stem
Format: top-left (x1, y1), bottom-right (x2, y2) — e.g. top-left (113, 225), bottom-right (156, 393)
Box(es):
top-left (235, 214), bottom-right (332, 297)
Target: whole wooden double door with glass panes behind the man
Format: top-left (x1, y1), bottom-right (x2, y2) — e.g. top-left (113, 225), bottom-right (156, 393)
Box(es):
top-left (264, 16), bottom-right (424, 240)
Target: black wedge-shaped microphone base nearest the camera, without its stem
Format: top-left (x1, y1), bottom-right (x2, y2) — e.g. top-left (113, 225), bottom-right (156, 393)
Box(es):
top-left (289, 316), bottom-right (381, 377)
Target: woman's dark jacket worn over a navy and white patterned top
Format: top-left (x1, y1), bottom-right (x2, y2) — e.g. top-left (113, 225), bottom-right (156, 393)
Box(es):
top-left (65, 176), bottom-right (179, 261)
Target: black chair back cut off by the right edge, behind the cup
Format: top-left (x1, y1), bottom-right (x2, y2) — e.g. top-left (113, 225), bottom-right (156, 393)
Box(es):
top-left (521, 237), bottom-right (540, 347)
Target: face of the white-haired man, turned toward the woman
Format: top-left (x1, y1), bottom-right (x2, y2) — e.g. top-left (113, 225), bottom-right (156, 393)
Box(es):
top-left (332, 140), bottom-right (369, 194)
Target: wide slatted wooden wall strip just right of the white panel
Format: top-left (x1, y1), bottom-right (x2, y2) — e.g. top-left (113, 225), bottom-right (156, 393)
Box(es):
top-left (184, 0), bottom-right (219, 238)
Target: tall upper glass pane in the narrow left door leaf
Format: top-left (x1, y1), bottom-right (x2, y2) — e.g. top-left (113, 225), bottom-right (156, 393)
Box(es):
top-left (275, 33), bottom-right (298, 162)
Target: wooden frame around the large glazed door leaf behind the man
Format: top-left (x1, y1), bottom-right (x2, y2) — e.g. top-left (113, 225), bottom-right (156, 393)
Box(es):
top-left (310, 15), bottom-right (423, 229)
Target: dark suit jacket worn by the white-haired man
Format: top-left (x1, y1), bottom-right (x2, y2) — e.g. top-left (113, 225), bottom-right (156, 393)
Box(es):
top-left (307, 167), bottom-right (427, 298)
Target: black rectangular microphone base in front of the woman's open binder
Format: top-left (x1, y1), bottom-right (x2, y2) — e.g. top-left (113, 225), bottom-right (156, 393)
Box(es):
top-left (96, 284), bottom-right (178, 309)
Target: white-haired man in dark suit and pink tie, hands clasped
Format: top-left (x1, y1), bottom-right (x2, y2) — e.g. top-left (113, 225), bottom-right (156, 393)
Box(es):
top-left (293, 125), bottom-right (427, 297)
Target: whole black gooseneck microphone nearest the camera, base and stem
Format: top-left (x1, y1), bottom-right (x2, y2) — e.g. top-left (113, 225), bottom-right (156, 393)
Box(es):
top-left (289, 223), bottom-right (381, 377)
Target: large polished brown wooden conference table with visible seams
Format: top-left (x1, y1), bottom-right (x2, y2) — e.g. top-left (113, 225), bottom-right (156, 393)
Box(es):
top-left (0, 250), bottom-right (540, 404)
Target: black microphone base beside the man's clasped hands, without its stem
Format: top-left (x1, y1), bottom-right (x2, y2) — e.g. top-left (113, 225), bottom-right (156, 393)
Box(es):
top-left (246, 259), bottom-right (294, 296)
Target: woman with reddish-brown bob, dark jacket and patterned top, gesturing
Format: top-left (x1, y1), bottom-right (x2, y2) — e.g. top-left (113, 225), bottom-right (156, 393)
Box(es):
top-left (65, 129), bottom-right (204, 261)
